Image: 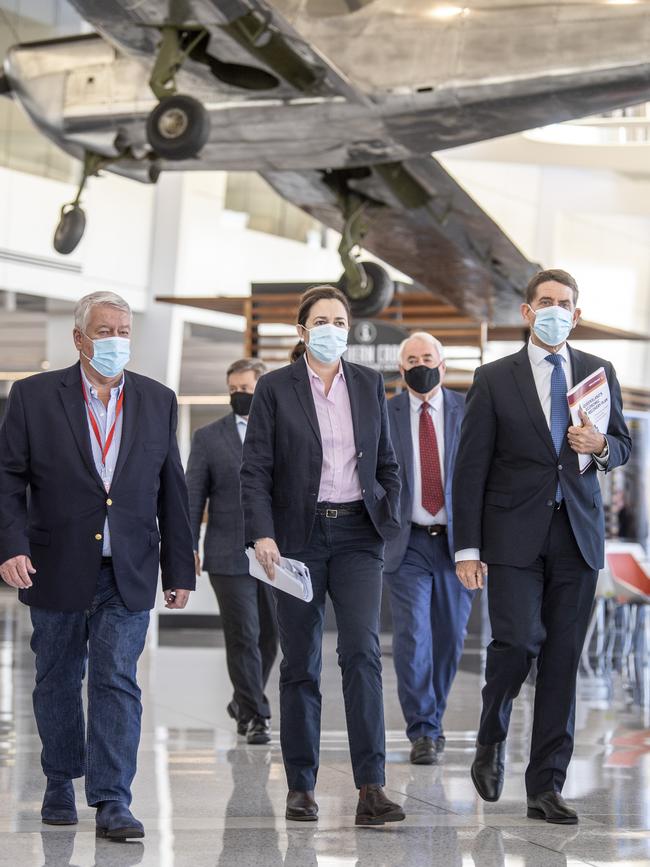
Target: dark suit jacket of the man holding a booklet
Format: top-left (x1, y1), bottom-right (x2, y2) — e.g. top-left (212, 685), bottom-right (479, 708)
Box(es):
top-left (453, 346), bottom-right (632, 569)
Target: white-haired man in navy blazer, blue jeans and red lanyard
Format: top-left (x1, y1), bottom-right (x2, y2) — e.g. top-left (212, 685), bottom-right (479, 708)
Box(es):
top-left (0, 292), bottom-right (195, 840)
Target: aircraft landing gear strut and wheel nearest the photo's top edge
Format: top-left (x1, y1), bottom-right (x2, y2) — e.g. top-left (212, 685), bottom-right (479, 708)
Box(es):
top-left (147, 24), bottom-right (210, 160)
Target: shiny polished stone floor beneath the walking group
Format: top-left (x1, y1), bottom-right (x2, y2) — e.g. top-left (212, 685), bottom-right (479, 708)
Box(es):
top-left (0, 591), bottom-right (650, 867)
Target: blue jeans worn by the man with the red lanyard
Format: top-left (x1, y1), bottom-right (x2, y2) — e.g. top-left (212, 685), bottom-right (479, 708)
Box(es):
top-left (30, 566), bottom-right (149, 807)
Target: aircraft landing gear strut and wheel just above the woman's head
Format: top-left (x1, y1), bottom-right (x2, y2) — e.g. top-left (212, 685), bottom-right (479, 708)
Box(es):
top-left (338, 195), bottom-right (395, 318)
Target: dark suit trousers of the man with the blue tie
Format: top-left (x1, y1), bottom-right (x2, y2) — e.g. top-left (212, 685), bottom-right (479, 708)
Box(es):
top-left (478, 506), bottom-right (598, 795)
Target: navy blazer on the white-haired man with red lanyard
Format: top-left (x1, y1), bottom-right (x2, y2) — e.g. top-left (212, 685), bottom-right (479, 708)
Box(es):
top-left (0, 364), bottom-right (195, 611)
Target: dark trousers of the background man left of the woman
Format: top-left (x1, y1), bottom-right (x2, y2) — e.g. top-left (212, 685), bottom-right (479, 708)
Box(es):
top-left (210, 573), bottom-right (278, 721)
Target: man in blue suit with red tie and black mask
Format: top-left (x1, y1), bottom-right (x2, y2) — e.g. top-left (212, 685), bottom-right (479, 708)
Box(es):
top-left (384, 332), bottom-right (473, 765)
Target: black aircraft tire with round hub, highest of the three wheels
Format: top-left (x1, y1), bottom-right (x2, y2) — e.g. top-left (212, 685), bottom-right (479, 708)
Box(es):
top-left (147, 94), bottom-right (210, 160)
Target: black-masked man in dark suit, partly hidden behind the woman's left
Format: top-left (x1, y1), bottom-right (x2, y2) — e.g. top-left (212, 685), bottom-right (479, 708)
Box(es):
top-left (186, 358), bottom-right (278, 744)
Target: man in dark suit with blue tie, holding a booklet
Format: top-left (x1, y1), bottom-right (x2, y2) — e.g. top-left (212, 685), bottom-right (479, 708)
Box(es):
top-left (453, 270), bottom-right (631, 824)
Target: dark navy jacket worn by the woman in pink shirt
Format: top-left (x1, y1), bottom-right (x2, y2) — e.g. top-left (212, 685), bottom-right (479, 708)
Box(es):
top-left (241, 358), bottom-right (400, 554)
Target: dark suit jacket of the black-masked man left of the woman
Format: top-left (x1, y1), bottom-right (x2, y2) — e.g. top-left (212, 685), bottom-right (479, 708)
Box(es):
top-left (185, 413), bottom-right (248, 575)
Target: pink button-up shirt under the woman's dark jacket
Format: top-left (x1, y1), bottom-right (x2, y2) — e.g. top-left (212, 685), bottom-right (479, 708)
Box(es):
top-left (305, 357), bottom-right (362, 503)
